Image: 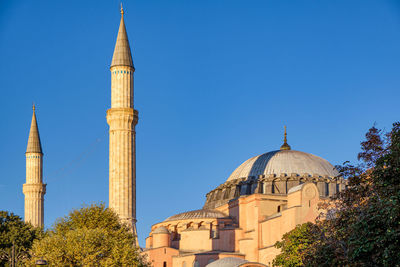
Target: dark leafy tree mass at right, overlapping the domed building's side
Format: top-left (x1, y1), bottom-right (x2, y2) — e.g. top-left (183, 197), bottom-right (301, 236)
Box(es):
top-left (276, 123), bottom-right (400, 266)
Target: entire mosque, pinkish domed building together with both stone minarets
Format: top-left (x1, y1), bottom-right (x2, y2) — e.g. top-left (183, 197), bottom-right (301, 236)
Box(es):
top-left (23, 7), bottom-right (346, 267)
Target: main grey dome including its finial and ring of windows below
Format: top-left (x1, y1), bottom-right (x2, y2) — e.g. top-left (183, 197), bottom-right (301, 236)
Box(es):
top-left (203, 133), bottom-right (345, 209)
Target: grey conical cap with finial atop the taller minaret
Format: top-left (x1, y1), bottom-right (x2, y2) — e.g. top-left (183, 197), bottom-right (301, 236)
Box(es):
top-left (111, 6), bottom-right (133, 68)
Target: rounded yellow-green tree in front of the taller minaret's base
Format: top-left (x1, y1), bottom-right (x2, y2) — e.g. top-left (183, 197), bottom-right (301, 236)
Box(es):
top-left (30, 204), bottom-right (146, 266)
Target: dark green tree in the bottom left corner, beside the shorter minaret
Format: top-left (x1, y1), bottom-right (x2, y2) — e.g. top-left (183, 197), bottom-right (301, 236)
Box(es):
top-left (0, 211), bottom-right (42, 266)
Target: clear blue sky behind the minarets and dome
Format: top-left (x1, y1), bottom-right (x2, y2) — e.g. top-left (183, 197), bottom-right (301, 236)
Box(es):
top-left (0, 0), bottom-right (400, 247)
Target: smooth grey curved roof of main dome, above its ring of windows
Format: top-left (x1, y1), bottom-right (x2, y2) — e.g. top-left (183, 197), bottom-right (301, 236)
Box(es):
top-left (227, 150), bottom-right (338, 181)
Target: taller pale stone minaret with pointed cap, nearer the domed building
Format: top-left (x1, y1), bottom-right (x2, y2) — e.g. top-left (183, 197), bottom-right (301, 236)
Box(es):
top-left (107, 5), bottom-right (138, 237)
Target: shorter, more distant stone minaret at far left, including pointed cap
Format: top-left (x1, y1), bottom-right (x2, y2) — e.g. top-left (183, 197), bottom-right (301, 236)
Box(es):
top-left (22, 106), bottom-right (46, 227)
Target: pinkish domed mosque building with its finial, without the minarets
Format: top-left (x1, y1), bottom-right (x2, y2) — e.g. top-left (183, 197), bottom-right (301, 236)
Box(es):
top-left (144, 129), bottom-right (345, 267)
